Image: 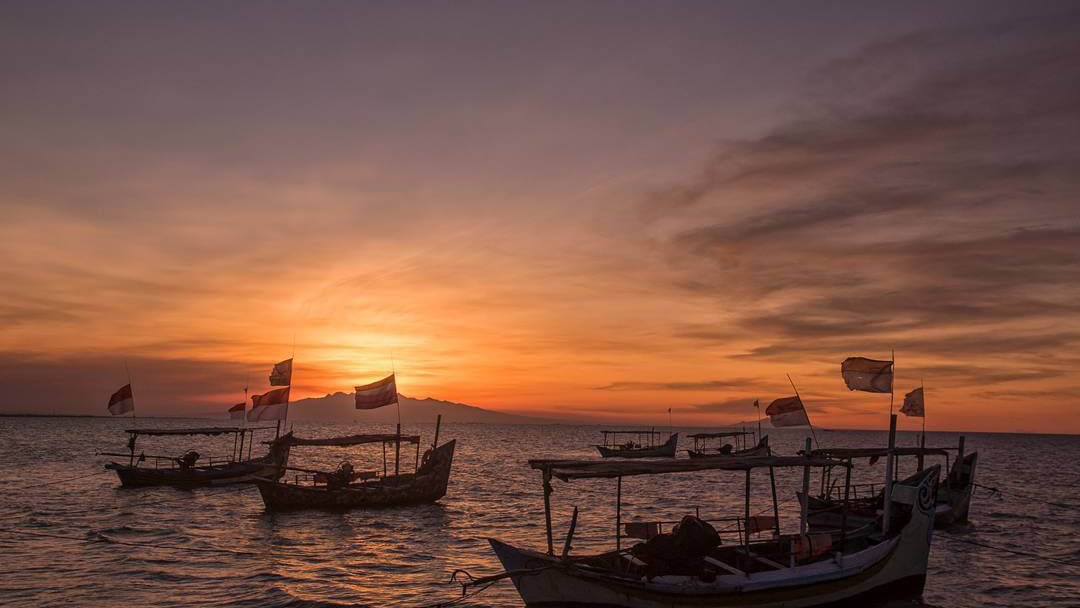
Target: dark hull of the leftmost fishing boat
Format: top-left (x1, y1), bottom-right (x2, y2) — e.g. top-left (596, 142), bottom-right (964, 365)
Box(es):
top-left (105, 446), bottom-right (288, 488)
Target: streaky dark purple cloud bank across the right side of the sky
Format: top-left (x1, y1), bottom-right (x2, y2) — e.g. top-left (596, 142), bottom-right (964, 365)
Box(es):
top-left (642, 14), bottom-right (1080, 395)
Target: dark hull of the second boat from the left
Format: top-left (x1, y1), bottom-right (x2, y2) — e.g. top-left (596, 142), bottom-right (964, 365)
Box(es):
top-left (255, 441), bottom-right (456, 511)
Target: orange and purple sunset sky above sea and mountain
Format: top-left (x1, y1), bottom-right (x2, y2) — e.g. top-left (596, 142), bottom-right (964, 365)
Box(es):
top-left (0, 1), bottom-right (1080, 433)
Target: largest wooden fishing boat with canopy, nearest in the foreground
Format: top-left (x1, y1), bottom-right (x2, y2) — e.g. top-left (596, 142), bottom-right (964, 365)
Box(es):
top-left (477, 427), bottom-right (939, 608)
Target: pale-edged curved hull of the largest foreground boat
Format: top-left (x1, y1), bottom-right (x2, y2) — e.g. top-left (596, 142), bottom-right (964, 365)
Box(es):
top-left (489, 472), bottom-right (936, 608)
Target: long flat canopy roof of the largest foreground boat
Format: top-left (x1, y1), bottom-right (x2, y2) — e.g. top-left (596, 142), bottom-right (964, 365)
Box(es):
top-left (529, 456), bottom-right (848, 482)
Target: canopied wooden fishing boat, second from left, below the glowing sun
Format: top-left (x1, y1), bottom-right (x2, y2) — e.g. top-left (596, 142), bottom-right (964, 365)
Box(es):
top-left (255, 417), bottom-right (456, 511)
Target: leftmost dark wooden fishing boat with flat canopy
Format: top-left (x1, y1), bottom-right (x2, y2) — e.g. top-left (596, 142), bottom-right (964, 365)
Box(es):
top-left (99, 427), bottom-right (289, 488)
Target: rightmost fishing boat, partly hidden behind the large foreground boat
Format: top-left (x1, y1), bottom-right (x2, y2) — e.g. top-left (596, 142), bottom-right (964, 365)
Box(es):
top-left (799, 437), bottom-right (978, 528)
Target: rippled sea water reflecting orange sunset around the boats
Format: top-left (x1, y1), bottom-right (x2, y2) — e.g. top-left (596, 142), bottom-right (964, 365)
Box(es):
top-left (0, 418), bottom-right (1080, 608)
